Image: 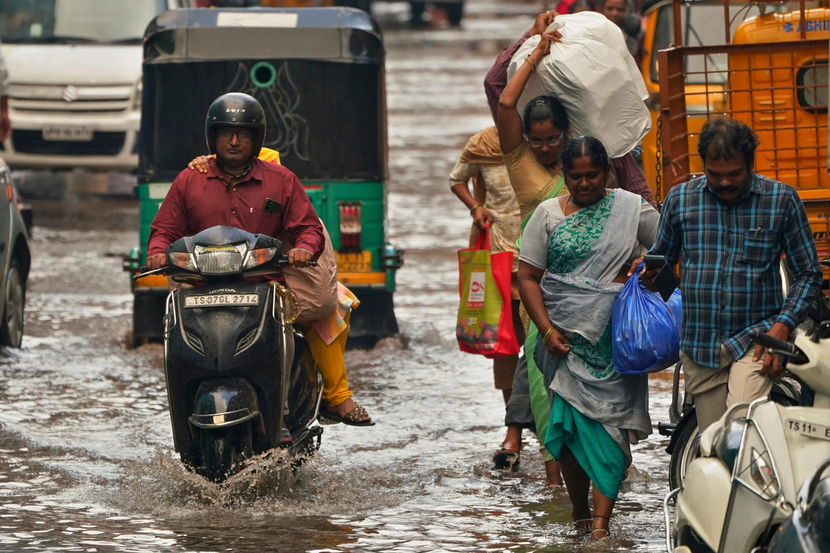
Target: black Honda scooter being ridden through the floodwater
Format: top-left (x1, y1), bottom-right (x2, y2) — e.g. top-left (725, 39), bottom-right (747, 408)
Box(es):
top-left (134, 226), bottom-right (323, 482)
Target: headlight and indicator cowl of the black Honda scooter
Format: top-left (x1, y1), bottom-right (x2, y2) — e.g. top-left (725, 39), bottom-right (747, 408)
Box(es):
top-left (167, 226), bottom-right (282, 276)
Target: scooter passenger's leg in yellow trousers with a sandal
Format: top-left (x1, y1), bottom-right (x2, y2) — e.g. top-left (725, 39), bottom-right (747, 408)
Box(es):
top-left (304, 313), bottom-right (372, 423)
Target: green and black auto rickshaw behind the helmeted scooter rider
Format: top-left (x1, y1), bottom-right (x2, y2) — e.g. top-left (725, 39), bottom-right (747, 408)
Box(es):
top-left (124, 8), bottom-right (402, 347)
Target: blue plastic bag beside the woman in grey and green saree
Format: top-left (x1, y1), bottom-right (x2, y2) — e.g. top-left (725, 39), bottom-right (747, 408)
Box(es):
top-left (611, 270), bottom-right (683, 374)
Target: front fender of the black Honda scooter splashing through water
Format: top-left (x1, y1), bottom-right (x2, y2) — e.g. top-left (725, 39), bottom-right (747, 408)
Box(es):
top-left (187, 378), bottom-right (265, 436)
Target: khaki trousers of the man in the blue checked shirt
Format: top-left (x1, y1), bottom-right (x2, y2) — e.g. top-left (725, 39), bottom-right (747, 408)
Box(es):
top-left (680, 346), bottom-right (772, 432)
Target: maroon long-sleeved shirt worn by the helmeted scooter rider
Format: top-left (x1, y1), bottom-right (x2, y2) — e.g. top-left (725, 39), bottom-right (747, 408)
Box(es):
top-left (147, 159), bottom-right (324, 274)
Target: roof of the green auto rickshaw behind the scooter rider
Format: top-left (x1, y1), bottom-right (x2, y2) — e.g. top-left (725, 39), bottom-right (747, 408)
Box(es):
top-left (144, 8), bottom-right (385, 64)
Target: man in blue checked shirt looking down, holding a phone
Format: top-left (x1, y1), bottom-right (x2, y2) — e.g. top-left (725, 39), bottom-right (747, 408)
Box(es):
top-left (641, 118), bottom-right (822, 431)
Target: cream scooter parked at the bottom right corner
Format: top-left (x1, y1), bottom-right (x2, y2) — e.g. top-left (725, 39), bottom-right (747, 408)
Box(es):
top-left (663, 312), bottom-right (830, 553)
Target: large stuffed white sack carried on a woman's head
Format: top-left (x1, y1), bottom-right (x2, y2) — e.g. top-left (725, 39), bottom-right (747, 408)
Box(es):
top-left (507, 12), bottom-right (651, 159)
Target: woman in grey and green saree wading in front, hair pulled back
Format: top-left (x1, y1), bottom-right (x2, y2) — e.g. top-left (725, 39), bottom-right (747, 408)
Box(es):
top-left (518, 136), bottom-right (659, 539)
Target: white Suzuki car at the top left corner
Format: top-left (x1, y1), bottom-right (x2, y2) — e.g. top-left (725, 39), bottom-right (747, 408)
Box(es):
top-left (0, 0), bottom-right (186, 171)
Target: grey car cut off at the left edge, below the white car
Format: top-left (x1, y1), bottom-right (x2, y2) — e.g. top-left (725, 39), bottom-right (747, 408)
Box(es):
top-left (0, 160), bottom-right (32, 348)
